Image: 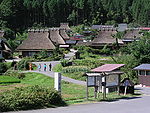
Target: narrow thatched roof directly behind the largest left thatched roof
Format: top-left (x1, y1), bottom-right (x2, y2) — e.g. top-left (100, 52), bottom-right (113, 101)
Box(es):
top-left (49, 28), bottom-right (65, 45)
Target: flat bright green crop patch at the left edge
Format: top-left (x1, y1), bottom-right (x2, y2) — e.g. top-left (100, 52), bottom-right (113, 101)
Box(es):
top-left (0, 76), bottom-right (20, 84)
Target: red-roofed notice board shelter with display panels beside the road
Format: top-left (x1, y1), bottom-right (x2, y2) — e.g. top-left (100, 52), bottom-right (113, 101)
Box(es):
top-left (86, 64), bottom-right (124, 99)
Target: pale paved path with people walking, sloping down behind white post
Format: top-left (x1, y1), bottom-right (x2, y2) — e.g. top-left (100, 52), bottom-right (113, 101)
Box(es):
top-left (27, 61), bottom-right (86, 85)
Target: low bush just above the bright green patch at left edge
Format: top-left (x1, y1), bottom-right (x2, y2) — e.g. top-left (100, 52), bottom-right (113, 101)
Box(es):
top-left (4, 70), bottom-right (25, 79)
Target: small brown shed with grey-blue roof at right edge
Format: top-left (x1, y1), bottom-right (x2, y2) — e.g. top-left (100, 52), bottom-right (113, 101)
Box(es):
top-left (134, 64), bottom-right (150, 86)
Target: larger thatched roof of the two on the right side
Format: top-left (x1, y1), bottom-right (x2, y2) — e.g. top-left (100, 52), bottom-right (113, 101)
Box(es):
top-left (92, 29), bottom-right (123, 46)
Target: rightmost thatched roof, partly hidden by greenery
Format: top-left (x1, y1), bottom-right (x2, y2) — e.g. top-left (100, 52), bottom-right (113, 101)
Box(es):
top-left (124, 29), bottom-right (141, 39)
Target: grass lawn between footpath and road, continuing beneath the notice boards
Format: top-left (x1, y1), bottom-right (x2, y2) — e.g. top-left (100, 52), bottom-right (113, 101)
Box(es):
top-left (0, 73), bottom-right (139, 104)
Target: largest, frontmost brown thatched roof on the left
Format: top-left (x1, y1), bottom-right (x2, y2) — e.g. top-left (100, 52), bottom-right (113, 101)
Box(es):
top-left (17, 29), bottom-right (55, 51)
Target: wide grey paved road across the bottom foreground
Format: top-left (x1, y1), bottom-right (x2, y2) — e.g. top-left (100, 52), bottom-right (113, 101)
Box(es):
top-left (5, 88), bottom-right (150, 113)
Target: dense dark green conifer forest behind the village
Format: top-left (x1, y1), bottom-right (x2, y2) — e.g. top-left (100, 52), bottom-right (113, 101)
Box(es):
top-left (0, 0), bottom-right (150, 32)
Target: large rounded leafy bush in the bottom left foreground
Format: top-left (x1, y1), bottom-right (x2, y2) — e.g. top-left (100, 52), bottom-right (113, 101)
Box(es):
top-left (0, 86), bottom-right (65, 111)
